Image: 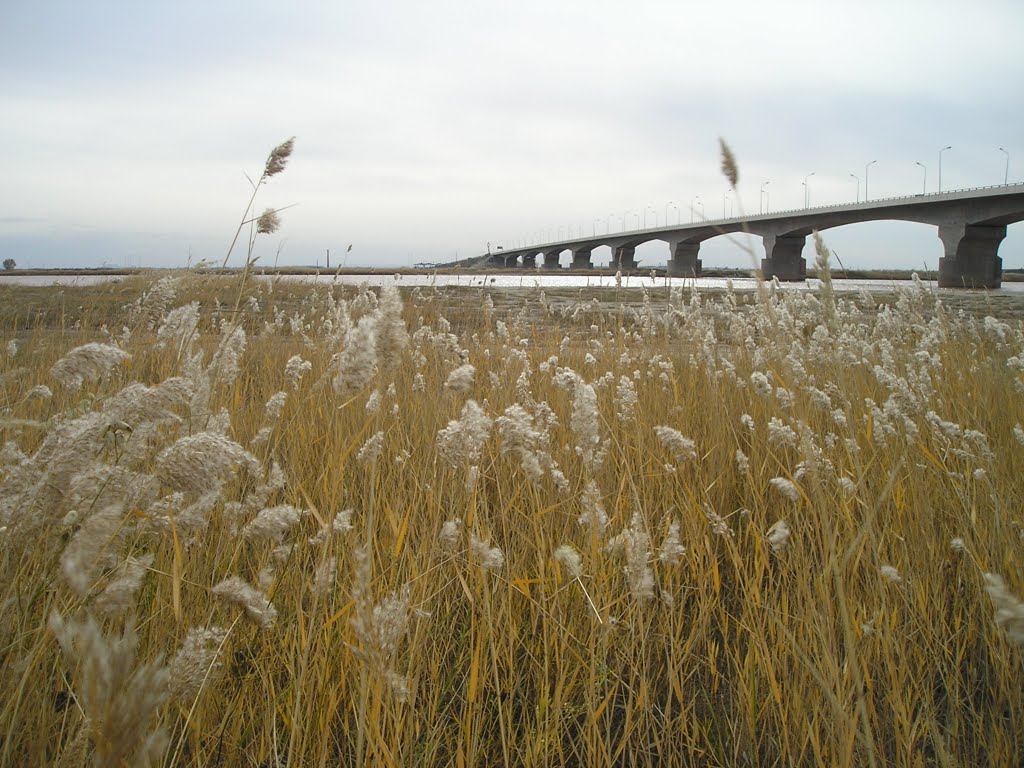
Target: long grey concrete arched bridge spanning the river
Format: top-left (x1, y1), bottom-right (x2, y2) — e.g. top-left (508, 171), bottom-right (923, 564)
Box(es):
top-left (480, 183), bottom-right (1024, 288)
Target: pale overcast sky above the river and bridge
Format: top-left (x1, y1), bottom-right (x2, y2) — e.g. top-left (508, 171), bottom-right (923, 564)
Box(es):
top-left (0, 0), bottom-right (1024, 268)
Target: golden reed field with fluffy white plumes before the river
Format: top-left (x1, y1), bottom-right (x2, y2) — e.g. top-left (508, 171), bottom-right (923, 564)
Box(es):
top-left (6, 143), bottom-right (1024, 768)
